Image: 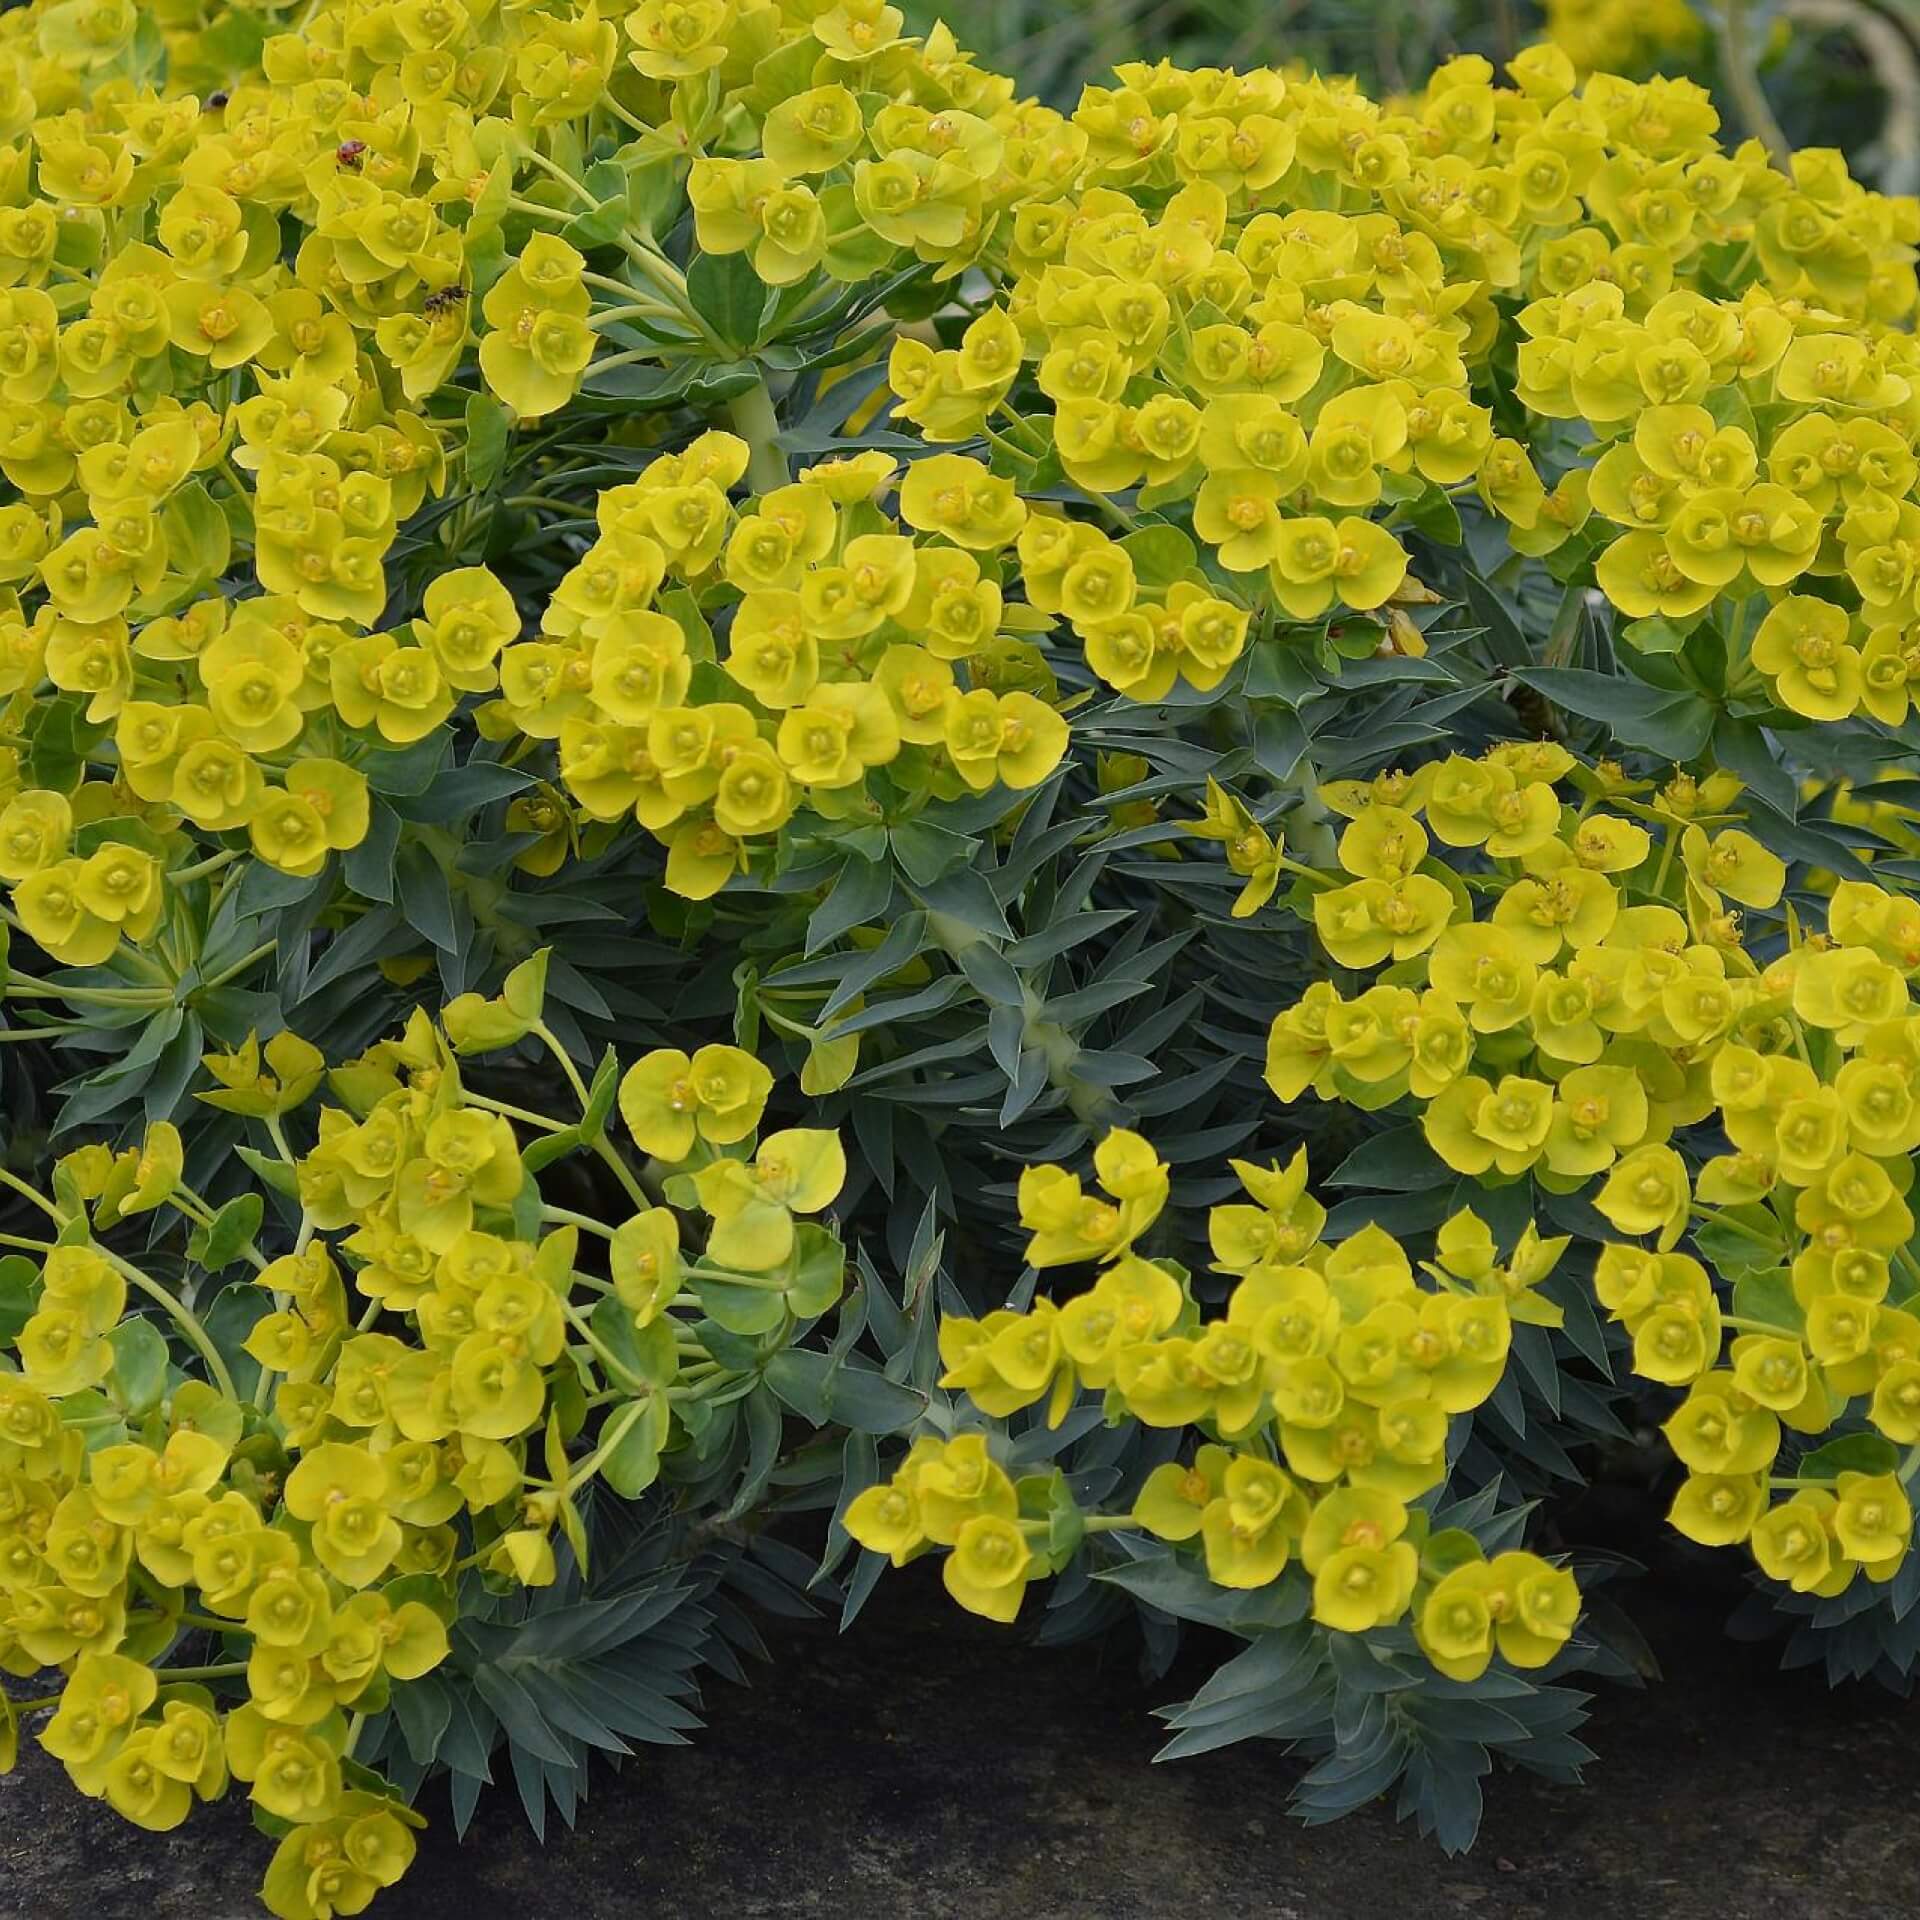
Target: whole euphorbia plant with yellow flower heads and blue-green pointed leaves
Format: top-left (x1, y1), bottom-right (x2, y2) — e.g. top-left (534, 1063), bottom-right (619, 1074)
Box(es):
top-left (0, 0), bottom-right (1920, 1896)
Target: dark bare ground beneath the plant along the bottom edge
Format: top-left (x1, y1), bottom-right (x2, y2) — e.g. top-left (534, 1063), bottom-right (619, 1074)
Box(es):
top-left (0, 1497), bottom-right (1920, 1920)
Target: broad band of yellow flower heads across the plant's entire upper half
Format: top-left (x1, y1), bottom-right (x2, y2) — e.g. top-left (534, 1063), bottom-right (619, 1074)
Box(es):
top-left (0, 0), bottom-right (1920, 990)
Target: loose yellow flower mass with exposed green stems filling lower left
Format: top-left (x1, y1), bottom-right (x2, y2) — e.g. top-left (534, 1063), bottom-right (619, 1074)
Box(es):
top-left (0, 962), bottom-right (845, 1920)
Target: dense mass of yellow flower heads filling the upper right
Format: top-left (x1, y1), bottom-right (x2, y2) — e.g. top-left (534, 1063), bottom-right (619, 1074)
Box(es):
top-left (891, 48), bottom-right (1920, 724)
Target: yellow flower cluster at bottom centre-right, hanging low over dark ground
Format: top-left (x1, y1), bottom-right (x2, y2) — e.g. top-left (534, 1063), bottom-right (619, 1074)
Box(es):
top-left (847, 1129), bottom-right (1580, 1678)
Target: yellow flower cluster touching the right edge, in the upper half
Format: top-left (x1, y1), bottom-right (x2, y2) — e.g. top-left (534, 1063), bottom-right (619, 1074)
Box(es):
top-left (1519, 303), bottom-right (1920, 726)
